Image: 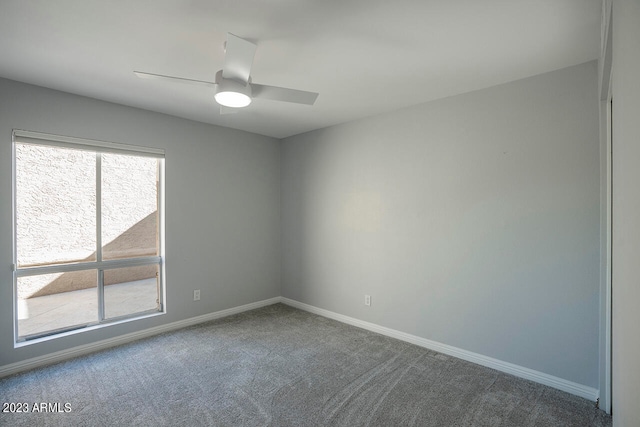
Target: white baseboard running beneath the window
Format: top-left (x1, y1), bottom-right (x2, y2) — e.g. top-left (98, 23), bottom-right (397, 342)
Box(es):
top-left (0, 297), bottom-right (282, 378)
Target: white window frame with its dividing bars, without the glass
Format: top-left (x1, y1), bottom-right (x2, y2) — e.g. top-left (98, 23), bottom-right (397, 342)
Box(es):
top-left (11, 129), bottom-right (166, 347)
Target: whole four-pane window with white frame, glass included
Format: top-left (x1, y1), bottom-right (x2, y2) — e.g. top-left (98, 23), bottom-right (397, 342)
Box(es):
top-left (13, 130), bottom-right (164, 342)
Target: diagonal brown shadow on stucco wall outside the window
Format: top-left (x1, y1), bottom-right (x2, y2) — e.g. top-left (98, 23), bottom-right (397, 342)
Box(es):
top-left (29, 211), bottom-right (158, 298)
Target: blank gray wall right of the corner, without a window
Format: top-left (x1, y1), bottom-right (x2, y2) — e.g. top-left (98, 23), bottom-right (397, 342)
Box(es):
top-left (282, 62), bottom-right (600, 388)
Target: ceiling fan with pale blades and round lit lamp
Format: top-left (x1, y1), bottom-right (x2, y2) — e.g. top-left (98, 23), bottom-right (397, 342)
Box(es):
top-left (134, 33), bottom-right (318, 114)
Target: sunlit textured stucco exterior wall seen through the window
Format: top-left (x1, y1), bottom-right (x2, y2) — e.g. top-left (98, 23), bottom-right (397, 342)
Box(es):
top-left (16, 143), bottom-right (158, 298)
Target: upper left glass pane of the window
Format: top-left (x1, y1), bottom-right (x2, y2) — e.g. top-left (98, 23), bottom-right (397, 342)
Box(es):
top-left (16, 144), bottom-right (96, 267)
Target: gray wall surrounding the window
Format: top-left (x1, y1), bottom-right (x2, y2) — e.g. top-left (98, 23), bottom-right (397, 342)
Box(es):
top-left (0, 79), bottom-right (280, 366)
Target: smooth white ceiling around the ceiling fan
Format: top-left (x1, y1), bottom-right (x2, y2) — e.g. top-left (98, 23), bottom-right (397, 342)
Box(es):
top-left (0, 0), bottom-right (601, 138)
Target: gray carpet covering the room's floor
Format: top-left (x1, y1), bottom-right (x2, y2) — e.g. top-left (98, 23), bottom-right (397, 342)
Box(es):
top-left (0, 304), bottom-right (611, 427)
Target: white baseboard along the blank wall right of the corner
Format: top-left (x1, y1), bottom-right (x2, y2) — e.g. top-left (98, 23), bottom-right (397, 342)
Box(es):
top-left (281, 297), bottom-right (600, 402)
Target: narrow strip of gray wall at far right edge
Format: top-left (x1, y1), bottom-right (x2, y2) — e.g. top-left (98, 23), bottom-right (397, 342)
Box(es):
top-left (612, 0), bottom-right (640, 427)
